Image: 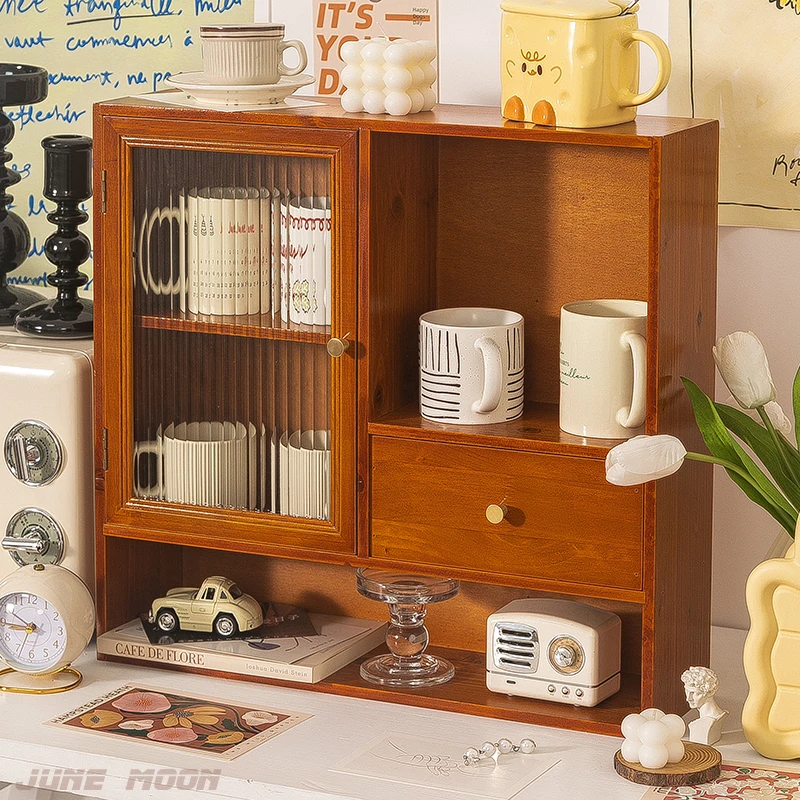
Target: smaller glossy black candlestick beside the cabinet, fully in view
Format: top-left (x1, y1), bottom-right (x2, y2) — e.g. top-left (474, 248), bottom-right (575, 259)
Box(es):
top-left (16, 134), bottom-right (94, 339)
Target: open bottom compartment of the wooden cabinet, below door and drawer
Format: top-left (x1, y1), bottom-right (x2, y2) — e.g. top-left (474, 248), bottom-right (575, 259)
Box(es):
top-left (95, 537), bottom-right (642, 734)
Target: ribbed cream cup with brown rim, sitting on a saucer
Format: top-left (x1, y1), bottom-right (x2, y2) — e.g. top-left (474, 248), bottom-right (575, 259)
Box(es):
top-left (200, 23), bottom-right (308, 86)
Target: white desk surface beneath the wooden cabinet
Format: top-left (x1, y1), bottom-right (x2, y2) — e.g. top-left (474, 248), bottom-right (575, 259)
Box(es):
top-left (0, 628), bottom-right (800, 800)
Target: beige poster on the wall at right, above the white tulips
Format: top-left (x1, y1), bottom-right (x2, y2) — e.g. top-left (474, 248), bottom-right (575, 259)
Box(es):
top-left (674, 0), bottom-right (800, 230)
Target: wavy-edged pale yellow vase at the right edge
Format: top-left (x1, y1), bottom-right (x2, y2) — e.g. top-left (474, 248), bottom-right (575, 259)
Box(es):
top-left (742, 546), bottom-right (800, 761)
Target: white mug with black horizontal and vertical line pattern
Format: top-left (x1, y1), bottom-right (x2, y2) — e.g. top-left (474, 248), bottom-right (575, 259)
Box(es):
top-left (419, 308), bottom-right (525, 425)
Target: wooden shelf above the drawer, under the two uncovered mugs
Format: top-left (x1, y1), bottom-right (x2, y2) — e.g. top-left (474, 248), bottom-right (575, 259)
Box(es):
top-left (369, 403), bottom-right (621, 459)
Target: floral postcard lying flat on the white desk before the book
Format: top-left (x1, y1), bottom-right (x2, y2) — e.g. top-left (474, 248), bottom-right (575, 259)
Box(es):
top-left (47, 684), bottom-right (311, 761)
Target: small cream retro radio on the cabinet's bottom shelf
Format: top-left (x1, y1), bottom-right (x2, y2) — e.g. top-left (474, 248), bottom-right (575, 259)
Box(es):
top-left (486, 599), bottom-right (622, 706)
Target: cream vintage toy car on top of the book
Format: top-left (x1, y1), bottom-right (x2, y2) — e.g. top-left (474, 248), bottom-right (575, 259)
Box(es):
top-left (150, 576), bottom-right (264, 639)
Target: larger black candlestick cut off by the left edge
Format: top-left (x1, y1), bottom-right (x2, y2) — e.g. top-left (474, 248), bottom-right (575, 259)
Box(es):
top-left (0, 64), bottom-right (47, 325)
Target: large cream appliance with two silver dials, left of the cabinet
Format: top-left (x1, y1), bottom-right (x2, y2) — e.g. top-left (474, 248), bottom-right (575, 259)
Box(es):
top-left (0, 333), bottom-right (94, 587)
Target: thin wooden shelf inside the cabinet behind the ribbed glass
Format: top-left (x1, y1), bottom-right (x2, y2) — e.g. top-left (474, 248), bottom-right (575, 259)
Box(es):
top-left (136, 312), bottom-right (331, 344)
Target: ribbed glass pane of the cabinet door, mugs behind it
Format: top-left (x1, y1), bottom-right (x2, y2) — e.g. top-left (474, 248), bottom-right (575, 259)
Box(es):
top-left (130, 148), bottom-right (336, 520)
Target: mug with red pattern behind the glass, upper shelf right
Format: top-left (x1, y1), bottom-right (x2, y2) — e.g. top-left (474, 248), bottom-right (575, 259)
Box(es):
top-left (281, 196), bottom-right (332, 325)
